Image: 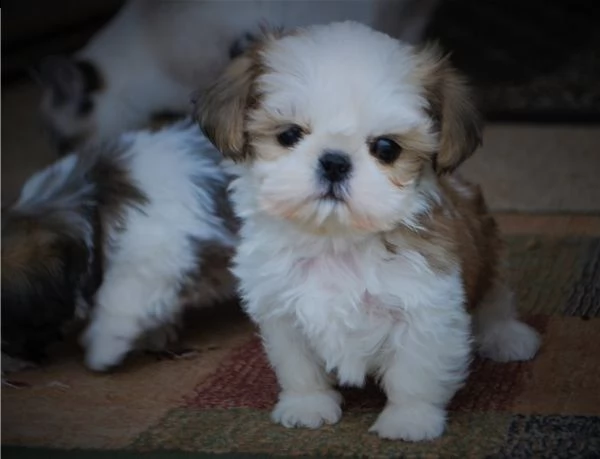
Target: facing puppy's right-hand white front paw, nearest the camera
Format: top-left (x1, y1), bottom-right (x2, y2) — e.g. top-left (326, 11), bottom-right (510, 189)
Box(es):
top-left (369, 403), bottom-right (446, 441)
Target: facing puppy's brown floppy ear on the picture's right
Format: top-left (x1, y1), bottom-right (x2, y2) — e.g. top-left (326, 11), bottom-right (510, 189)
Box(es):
top-left (418, 46), bottom-right (482, 174)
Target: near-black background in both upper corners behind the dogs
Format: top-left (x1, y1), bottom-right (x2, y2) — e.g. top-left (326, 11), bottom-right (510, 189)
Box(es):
top-left (2, 0), bottom-right (600, 123)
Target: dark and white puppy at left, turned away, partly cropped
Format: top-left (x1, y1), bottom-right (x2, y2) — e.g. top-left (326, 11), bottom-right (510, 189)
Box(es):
top-left (2, 121), bottom-right (237, 371)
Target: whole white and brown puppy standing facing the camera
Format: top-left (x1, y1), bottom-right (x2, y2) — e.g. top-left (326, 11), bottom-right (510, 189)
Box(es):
top-left (197, 22), bottom-right (539, 441)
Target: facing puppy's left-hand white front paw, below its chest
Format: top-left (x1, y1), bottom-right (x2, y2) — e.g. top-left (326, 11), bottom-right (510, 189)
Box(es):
top-left (271, 390), bottom-right (342, 429)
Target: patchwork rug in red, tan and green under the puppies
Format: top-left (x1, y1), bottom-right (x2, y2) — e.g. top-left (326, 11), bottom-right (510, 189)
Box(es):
top-left (2, 215), bottom-right (600, 459)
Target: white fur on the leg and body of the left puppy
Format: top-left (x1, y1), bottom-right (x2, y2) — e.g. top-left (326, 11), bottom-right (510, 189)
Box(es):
top-left (76, 126), bottom-right (235, 370)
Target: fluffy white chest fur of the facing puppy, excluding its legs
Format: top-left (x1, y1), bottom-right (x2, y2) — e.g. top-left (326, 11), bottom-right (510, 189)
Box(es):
top-left (234, 221), bottom-right (463, 385)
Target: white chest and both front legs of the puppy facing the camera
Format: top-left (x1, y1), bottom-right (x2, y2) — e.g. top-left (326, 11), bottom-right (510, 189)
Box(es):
top-left (234, 217), bottom-right (471, 440)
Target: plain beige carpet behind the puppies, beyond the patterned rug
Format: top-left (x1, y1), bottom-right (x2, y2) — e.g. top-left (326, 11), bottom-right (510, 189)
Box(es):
top-left (2, 84), bottom-right (600, 212)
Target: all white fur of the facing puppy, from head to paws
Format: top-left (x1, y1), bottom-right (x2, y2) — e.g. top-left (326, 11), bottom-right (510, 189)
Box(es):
top-left (225, 23), bottom-right (537, 441)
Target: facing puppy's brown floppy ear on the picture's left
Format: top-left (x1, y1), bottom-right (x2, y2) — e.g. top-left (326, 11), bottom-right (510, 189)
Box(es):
top-left (193, 52), bottom-right (261, 161)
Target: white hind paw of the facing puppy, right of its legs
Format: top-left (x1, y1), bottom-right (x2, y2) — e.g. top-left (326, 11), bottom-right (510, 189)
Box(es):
top-left (479, 320), bottom-right (540, 362)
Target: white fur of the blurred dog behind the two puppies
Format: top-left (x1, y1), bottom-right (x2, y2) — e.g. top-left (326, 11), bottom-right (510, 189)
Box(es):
top-left (43, 0), bottom-right (438, 147)
